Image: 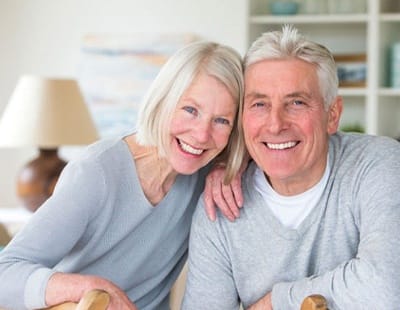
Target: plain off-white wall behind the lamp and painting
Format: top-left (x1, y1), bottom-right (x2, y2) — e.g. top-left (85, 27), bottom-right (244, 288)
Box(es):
top-left (0, 0), bottom-right (247, 207)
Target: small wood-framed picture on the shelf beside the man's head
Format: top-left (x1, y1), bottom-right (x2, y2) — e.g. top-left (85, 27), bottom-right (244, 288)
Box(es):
top-left (333, 54), bottom-right (367, 87)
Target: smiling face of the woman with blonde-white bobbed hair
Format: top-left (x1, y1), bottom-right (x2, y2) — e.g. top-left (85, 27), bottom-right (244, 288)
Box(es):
top-left (167, 73), bottom-right (237, 174)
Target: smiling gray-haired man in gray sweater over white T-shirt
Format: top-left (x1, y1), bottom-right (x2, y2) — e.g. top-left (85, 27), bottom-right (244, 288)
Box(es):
top-left (183, 26), bottom-right (400, 310)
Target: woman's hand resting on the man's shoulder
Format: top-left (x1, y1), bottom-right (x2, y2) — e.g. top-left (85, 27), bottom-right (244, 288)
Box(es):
top-left (204, 166), bottom-right (244, 221)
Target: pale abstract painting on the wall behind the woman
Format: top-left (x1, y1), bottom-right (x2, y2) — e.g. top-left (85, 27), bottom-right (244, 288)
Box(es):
top-left (78, 34), bottom-right (197, 137)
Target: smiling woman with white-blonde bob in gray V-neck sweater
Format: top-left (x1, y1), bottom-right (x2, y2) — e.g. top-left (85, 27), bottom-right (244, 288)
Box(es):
top-left (0, 42), bottom-right (244, 310)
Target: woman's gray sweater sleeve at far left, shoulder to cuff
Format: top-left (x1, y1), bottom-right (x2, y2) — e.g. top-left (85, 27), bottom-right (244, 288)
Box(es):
top-left (0, 159), bottom-right (104, 309)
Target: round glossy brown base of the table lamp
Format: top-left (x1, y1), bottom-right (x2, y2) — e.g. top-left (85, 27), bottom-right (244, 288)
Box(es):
top-left (17, 148), bottom-right (67, 212)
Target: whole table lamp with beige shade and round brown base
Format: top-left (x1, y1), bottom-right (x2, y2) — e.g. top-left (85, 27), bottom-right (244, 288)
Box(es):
top-left (0, 75), bottom-right (98, 212)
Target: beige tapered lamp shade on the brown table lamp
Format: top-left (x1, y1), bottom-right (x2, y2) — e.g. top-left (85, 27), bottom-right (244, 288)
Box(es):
top-left (0, 75), bottom-right (98, 149)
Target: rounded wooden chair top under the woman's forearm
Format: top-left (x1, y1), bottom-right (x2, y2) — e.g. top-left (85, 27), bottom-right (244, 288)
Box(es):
top-left (46, 289), bottom-right (110, 310)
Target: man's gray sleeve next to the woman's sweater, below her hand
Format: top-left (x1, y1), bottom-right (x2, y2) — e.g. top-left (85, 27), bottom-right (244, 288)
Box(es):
top-left (182, 197), bottom-right (239, 310)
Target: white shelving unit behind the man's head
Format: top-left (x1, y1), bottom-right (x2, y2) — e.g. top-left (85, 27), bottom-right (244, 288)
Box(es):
top-left (247, 0), bottom-right (400, 138)
